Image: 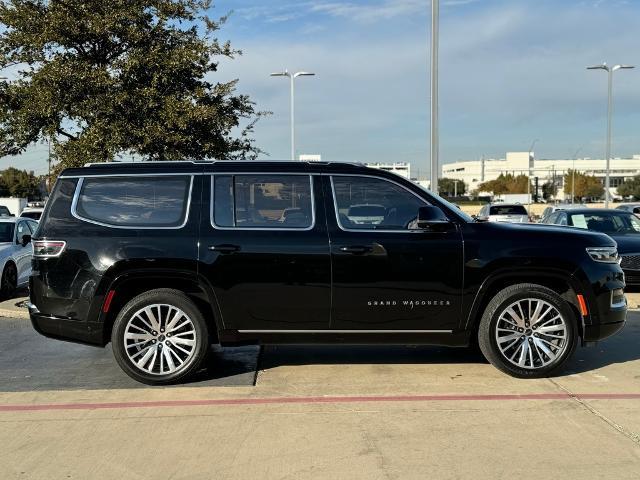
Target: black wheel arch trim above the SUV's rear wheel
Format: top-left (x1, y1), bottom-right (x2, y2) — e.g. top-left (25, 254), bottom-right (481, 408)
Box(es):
top-left (94, 269), bottom-right (223, 345)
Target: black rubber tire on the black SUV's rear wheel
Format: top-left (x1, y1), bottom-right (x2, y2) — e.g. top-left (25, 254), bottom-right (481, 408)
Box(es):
top-left (111, 288), bottom-right (209, 385)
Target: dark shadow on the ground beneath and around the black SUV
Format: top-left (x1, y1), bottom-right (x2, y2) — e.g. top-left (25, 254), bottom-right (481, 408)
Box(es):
top-left (0, 312), bottom-right (640, 392)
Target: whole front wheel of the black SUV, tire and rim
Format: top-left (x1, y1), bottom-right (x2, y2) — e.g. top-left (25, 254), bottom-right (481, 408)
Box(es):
top-left (478, 284), bottom-right (578, 378)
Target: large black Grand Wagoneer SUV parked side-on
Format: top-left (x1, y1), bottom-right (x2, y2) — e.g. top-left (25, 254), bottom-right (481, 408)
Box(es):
top-left (30, 161), bottom-right (627, 384)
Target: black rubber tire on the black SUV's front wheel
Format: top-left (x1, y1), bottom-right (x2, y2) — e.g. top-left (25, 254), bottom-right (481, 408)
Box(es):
top-left (478, 283), bottom-right (578, 378)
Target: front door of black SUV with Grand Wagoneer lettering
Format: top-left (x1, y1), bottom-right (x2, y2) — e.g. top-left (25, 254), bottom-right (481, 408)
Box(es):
top-left (324, 175), bottom-right (463, 332)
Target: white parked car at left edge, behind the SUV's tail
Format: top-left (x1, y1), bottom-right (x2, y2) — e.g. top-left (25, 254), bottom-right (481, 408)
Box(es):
top-left (0, 217), bottom-right (38, 300)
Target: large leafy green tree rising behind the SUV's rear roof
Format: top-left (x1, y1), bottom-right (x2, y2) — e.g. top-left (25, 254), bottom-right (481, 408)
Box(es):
top-left (0, 0), bottom-right (262, 172)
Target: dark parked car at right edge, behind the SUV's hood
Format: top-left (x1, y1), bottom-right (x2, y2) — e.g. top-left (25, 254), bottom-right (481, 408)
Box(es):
top-left (547, 208), bottom-right (640, 287)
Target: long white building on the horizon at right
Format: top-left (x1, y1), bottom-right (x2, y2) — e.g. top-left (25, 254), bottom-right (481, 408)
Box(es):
top-left (442, 152), bottom-right (640, 200)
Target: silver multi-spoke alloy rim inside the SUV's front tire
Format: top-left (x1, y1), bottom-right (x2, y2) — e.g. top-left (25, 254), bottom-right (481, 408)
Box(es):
top-left (495, 298), bottom-right (569, 369)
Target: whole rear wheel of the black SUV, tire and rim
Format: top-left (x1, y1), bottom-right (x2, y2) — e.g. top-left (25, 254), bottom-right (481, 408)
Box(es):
top-left (111, 289), bottom-right (209, 385)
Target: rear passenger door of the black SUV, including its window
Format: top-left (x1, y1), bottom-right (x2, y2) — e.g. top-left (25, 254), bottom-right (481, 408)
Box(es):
top-left (199, 172), bottom-right (331, 333)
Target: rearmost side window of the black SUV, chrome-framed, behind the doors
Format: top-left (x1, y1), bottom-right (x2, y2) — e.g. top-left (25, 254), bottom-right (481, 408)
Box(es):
top-left (74, 176), bottom-right (191, 228)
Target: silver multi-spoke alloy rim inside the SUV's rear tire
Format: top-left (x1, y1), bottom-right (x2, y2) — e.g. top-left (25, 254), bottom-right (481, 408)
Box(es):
top-left (124, 304), bottom-right (197, 375)
